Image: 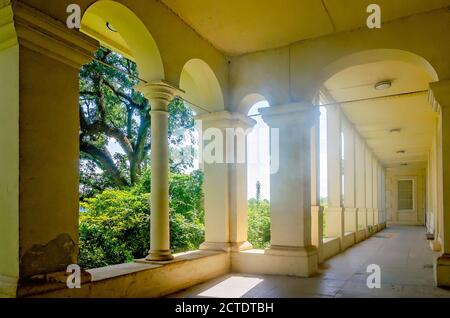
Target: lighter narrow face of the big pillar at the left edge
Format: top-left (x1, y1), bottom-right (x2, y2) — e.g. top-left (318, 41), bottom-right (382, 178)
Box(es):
top-left (0, 45), bottom-right (19, 284)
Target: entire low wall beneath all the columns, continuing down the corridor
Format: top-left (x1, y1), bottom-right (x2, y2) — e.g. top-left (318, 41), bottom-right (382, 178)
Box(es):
top-left (27, 223), bottom-right (386, 298)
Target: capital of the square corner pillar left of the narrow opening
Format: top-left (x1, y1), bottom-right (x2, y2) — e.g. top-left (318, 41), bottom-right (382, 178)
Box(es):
top-left (195, 111), bottom-right (256, 129)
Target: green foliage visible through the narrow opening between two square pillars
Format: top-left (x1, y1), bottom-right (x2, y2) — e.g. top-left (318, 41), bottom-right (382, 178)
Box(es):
top-left (248, 199), bottom-right (270, 249)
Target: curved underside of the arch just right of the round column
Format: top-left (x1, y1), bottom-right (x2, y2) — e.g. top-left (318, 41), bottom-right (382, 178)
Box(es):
top-left (180, 58), bottom-right (225, 114)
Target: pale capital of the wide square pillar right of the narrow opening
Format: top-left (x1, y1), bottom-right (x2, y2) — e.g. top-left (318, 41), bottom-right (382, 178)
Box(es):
top-left (260, 103), bottom-right (320, 128)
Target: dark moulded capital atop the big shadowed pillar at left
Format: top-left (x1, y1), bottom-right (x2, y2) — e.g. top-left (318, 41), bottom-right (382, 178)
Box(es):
top-left (12, 0), bottom-right (99, 68)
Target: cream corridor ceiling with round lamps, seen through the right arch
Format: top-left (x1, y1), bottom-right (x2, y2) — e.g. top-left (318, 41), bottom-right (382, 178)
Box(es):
top-left (325, 60), bottom-right (436, 168)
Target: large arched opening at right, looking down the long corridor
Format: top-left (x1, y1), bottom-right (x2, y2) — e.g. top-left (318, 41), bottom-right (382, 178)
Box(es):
top-left (318, 49), bottom-right (438, 257)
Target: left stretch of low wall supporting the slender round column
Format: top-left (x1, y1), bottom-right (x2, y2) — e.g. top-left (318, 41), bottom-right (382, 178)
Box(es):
top-left (30, 251), bottom-right (231, 298)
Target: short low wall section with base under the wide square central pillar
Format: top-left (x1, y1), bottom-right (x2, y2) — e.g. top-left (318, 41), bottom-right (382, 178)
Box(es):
top-left (231, 246), bottom-right (319, 277)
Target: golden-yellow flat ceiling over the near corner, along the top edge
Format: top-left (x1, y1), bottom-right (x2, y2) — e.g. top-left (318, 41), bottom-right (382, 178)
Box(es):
top-left (162, 0), bottom-right (450, 55)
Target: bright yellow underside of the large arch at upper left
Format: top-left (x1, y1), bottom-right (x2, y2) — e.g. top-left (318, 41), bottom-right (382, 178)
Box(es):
top-left (81, 0), bottom-right (165, 82)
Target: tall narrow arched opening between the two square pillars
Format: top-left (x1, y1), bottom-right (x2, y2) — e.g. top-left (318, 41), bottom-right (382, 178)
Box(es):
top-left (240, 94), bottom-right (270, 249)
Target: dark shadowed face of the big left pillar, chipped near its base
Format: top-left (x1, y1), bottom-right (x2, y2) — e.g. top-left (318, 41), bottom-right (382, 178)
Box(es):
top-left (20, 47), bottom-right (79, 277)
